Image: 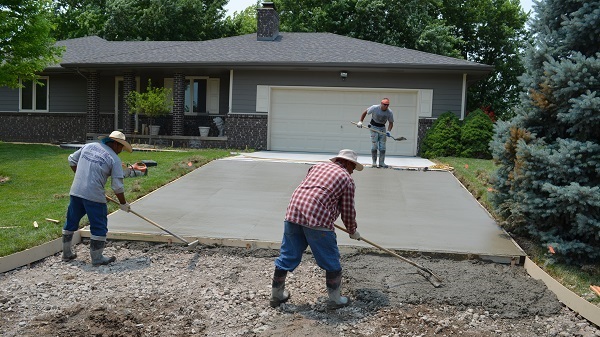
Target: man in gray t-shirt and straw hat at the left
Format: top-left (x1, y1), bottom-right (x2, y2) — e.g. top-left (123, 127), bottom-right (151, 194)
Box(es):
top-left (62, 131), bottom-right (133, 266)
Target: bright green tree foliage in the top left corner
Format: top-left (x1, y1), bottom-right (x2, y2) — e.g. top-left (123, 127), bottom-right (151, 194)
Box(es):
top-left (0, 0), bottom-right (62, 88)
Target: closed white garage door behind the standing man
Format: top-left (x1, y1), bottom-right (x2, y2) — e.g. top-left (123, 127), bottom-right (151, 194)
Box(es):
top-left (269, 87), bottom-right (418, 156)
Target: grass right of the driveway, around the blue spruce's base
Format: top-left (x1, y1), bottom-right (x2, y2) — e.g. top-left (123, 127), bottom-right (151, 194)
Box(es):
top-left (433, 157), bottom-right (600, 306)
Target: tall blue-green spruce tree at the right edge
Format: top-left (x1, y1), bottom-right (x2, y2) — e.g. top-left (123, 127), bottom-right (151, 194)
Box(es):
top-left (492, 0), bottom-right (600, 264)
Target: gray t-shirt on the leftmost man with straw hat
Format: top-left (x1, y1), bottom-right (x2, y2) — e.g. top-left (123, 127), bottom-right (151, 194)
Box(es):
top-left (69, 143), bottom-right (125, 203)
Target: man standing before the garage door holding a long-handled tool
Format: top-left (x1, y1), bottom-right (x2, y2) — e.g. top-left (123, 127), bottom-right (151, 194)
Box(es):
top-left (356, 98), bottom-right (394, 168)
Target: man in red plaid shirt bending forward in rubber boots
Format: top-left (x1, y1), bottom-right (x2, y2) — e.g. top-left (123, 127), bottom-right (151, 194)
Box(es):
top-left (270, 150), bottom-right (363, 309)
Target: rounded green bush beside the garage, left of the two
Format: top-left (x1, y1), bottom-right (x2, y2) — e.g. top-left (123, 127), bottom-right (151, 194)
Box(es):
top-left (420, 111), bottom-right (461, 158)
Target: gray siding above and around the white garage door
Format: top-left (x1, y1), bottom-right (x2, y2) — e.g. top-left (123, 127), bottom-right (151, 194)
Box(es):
top-left (232, 70), bottom-right (462, 117)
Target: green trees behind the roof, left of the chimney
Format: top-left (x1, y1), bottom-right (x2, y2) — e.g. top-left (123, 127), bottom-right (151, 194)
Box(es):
top-left (54, 0), bottom-right (233, 41)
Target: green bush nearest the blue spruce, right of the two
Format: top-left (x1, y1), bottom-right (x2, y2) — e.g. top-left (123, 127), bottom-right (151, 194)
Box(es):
top-left (460, 109), bottom-right (494, 159)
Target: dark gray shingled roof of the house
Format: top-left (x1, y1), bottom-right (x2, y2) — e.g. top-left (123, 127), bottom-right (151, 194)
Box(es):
top-left (57, 33), bottom-right (493, 72)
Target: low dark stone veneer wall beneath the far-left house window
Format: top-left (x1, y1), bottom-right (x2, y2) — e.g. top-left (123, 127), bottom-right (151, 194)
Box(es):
top-left (0, 113), bottom-right (86, 144)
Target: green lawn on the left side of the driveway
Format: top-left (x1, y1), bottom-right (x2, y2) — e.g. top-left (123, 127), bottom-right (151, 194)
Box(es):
top-left (0, 142), bottom-right (230, 256)
